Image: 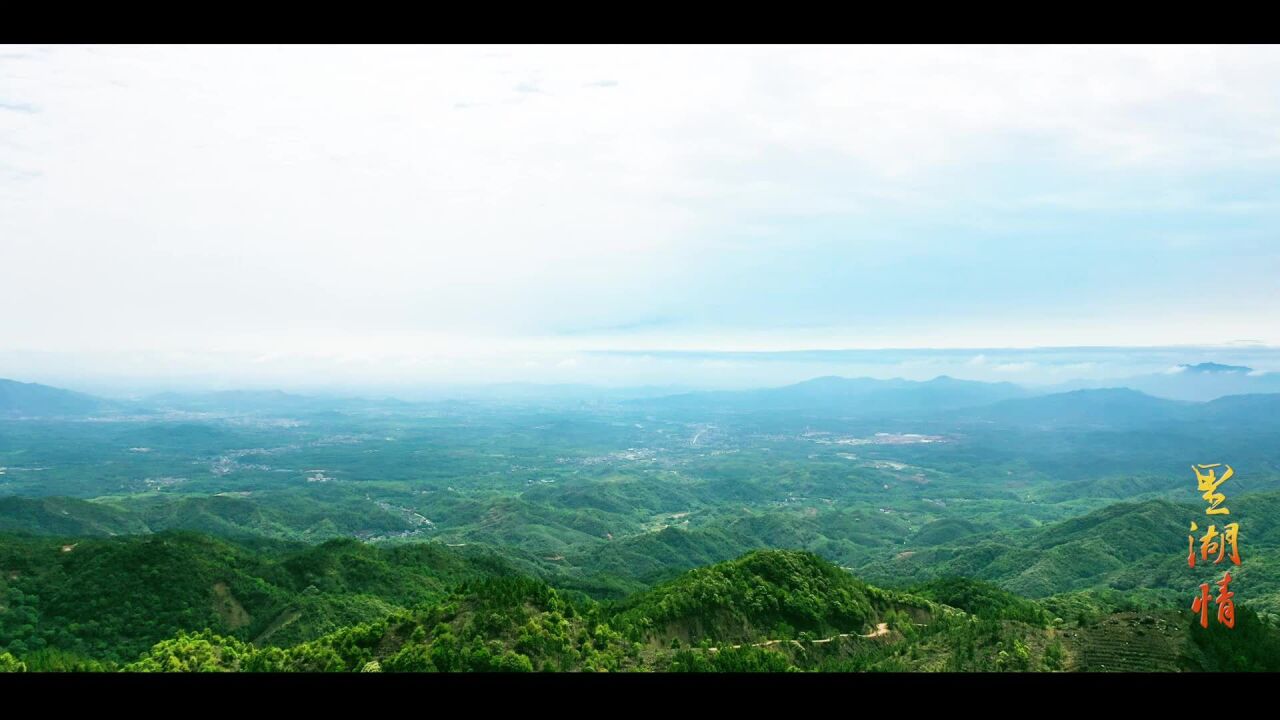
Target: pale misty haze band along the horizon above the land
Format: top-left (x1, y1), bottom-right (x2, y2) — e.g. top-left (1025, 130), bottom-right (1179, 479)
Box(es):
top-left (0, 346), bottom-right (1280, 400)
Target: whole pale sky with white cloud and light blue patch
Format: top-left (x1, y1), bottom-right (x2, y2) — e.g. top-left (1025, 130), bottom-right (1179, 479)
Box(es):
top-left (0, 46), bottom-right (1280, 386)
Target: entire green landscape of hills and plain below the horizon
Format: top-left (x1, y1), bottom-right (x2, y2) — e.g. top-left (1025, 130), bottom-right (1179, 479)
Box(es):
top-left (0, 378), bottom-right (1280, 671)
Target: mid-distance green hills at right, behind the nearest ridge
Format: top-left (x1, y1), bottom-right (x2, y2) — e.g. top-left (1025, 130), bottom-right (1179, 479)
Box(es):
top-left (565, 492), bottom-right (1280, 612)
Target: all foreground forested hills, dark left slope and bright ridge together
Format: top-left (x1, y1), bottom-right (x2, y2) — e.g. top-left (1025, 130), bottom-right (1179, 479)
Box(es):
top-left (0, 543), bottom-right (1280, 671)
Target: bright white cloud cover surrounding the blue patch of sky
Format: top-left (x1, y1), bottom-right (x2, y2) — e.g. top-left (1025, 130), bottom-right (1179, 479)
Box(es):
top-left (0, 46), bottom-right (1280, 384)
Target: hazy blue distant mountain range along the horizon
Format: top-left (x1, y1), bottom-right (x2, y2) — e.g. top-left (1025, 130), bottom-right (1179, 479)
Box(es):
top-left (0, 363), bottom-right (1280, 427)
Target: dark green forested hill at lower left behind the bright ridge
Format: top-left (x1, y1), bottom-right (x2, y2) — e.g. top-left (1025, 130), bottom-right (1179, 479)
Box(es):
top-left (0, 533), bottom-right (509, 662)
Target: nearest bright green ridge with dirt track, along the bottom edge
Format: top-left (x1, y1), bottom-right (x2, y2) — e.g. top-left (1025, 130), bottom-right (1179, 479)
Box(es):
top-left (10, 548), bottom-right (1280, 673)
